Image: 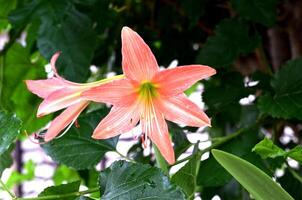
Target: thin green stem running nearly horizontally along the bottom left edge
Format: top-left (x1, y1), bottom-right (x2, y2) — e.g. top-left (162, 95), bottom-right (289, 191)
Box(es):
top-left (15, 187), bottom-right (99, 200)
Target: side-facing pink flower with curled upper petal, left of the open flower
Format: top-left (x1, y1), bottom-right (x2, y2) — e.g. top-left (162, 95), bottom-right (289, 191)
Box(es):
top-left (25, 52), bottom-right (123, 142)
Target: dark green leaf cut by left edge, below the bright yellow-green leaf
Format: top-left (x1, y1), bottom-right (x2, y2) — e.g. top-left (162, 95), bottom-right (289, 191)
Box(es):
top-left (0, 110), bottom-right (21, 155)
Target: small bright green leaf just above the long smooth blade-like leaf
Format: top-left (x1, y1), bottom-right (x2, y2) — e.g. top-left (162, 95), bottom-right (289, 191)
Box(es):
top-left (252, 138), bottom-right (285, 159)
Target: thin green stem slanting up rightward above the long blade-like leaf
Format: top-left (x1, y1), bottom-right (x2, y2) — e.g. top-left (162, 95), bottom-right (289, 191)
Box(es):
top-left (171, 128), bottom-right (246, 166)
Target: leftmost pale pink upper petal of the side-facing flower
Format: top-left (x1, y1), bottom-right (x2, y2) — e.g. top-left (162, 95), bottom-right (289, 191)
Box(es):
top-left (25, 77), bottom-right (67, 98)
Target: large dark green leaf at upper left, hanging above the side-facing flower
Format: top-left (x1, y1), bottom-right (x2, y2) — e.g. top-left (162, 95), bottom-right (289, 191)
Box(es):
top-left (9, 0), bottom-right (96, 82)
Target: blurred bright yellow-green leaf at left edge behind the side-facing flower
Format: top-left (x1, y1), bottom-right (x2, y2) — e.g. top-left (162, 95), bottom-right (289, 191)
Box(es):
top-left (0, 43), bottom-right (51, 133)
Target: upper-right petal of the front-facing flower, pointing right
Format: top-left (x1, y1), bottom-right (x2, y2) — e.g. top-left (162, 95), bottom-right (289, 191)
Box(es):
top-left (152, 65), bottom-right (216, 96)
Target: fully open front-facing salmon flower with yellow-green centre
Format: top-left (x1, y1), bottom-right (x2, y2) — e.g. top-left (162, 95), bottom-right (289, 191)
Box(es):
top-left (82, 27), bottom-right (216, 164)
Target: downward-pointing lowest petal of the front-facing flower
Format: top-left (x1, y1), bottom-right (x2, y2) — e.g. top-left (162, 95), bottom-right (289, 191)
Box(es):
top-left (141, 107), bottom-right (175, 164)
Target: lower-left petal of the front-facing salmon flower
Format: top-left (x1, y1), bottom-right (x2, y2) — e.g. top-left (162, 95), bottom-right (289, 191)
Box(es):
top-left (92, 105), bottom-right (139, 139)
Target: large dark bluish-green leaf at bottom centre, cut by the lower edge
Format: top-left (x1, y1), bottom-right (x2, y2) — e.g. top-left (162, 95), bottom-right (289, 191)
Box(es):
top-left (100, 161), bottom-right (185, 200)
